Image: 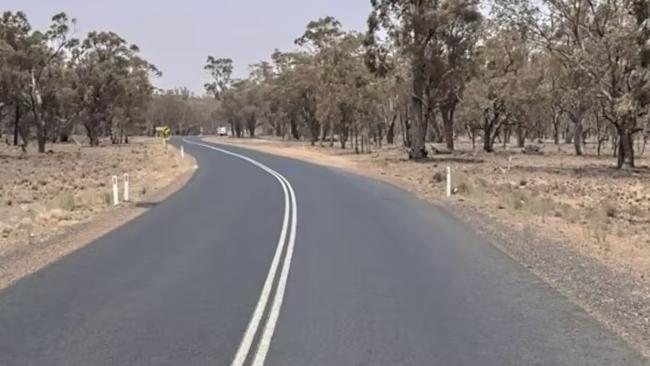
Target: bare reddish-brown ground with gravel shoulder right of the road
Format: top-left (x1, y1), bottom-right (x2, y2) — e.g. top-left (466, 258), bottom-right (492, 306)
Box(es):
top-left (210, 138), bottom-right (650, 356)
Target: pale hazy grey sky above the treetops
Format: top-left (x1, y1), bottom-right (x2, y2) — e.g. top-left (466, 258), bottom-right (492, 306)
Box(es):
top-left (0, 0), bottom-right (370, 93)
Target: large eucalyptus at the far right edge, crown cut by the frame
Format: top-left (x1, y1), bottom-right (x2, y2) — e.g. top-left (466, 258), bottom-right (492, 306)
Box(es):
top-left (497, 0), bottom-right (650, 168)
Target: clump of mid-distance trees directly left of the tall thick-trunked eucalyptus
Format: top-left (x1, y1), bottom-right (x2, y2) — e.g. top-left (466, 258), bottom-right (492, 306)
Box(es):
top-left (210, 17), bottom-right (394, 152)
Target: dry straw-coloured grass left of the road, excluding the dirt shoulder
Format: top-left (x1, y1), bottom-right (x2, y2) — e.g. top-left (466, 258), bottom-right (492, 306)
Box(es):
top-left (0, 139), bottom-right (194, 261)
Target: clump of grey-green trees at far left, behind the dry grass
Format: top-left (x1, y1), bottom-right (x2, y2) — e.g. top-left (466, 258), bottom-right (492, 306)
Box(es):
top-left (0, 12), bottom-right (160, 152)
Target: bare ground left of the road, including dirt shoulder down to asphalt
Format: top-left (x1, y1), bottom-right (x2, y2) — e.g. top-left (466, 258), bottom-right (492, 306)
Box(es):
top-left (0, 138), bottom-right (196, 289)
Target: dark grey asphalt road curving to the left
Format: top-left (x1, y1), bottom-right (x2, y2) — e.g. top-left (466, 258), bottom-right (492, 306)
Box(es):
top-left (0, 139), bottom-right (645, 366)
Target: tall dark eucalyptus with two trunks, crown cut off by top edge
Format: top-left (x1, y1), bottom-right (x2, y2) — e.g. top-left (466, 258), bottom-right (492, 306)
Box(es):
top-left (368, 0), bottom-right (481, 159)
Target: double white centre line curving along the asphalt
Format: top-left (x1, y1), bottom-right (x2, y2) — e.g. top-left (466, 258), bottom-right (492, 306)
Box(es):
top-left (183, 139), bottom-right (297, 366)
